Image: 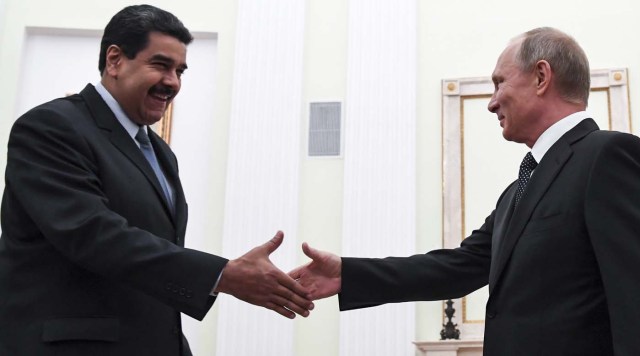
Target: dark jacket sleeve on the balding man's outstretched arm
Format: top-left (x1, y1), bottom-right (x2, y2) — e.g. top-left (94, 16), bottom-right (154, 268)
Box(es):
top-left (339, 211), bottom-right (495, 310)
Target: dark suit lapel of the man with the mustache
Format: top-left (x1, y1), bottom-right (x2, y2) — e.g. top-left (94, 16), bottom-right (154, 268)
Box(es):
top-left (80, 84), bottom-right (179, 219)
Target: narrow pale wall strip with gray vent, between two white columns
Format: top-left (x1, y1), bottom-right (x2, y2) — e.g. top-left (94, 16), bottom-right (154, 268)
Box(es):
top-left (296, 0), bottom-right (347, 355)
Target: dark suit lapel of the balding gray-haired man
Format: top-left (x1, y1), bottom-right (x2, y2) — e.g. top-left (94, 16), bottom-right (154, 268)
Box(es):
top-left (489, 119), bottom-right (598, 289)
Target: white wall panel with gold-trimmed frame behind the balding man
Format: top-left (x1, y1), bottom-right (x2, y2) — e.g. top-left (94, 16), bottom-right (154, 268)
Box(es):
top-left (442, 68), bottom-right (631, 339)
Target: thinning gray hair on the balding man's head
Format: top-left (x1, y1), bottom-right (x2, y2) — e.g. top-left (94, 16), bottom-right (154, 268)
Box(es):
top-left (514, 27), bottom-right (591, 105)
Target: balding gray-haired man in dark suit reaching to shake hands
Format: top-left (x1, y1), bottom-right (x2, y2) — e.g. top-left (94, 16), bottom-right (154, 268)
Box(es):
top-left (290, 28), bottom-right (640, 356)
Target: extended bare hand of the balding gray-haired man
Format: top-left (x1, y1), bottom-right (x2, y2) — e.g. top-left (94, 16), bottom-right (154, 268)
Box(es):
top-left (289, 242), bottom-right (342, 300)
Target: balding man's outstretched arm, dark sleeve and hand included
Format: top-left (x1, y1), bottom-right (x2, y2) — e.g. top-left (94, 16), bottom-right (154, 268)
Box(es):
top-left (289, 214), bottom-right (494, 310)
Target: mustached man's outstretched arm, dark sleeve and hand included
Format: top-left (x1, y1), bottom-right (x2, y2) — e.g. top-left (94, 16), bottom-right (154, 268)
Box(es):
top-left (3, 105), bottom-right (311, 319)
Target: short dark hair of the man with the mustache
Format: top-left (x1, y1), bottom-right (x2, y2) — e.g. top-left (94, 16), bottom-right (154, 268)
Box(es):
top-left (98, 5), bottom-right (193, 74)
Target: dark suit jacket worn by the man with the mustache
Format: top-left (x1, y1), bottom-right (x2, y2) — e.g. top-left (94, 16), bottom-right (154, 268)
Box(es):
top-left (0, 85), bottom-right (227, 356)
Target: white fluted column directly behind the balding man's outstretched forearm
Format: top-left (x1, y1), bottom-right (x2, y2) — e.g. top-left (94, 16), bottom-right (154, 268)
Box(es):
top-left (340, 0), bottom-right (417, 356)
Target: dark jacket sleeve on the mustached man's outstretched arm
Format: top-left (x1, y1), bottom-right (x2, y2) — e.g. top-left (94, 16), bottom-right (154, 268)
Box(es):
top-left (3, 104), bottom-right (227, 319)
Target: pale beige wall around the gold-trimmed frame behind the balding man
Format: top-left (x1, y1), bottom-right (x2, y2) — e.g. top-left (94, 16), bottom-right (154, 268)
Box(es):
top-left (417, 0), bottom-right (640, 340)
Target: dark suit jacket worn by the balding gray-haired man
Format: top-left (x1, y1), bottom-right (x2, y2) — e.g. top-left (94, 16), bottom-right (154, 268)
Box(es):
top-left (340, 119), bottom-right (640, 356)
